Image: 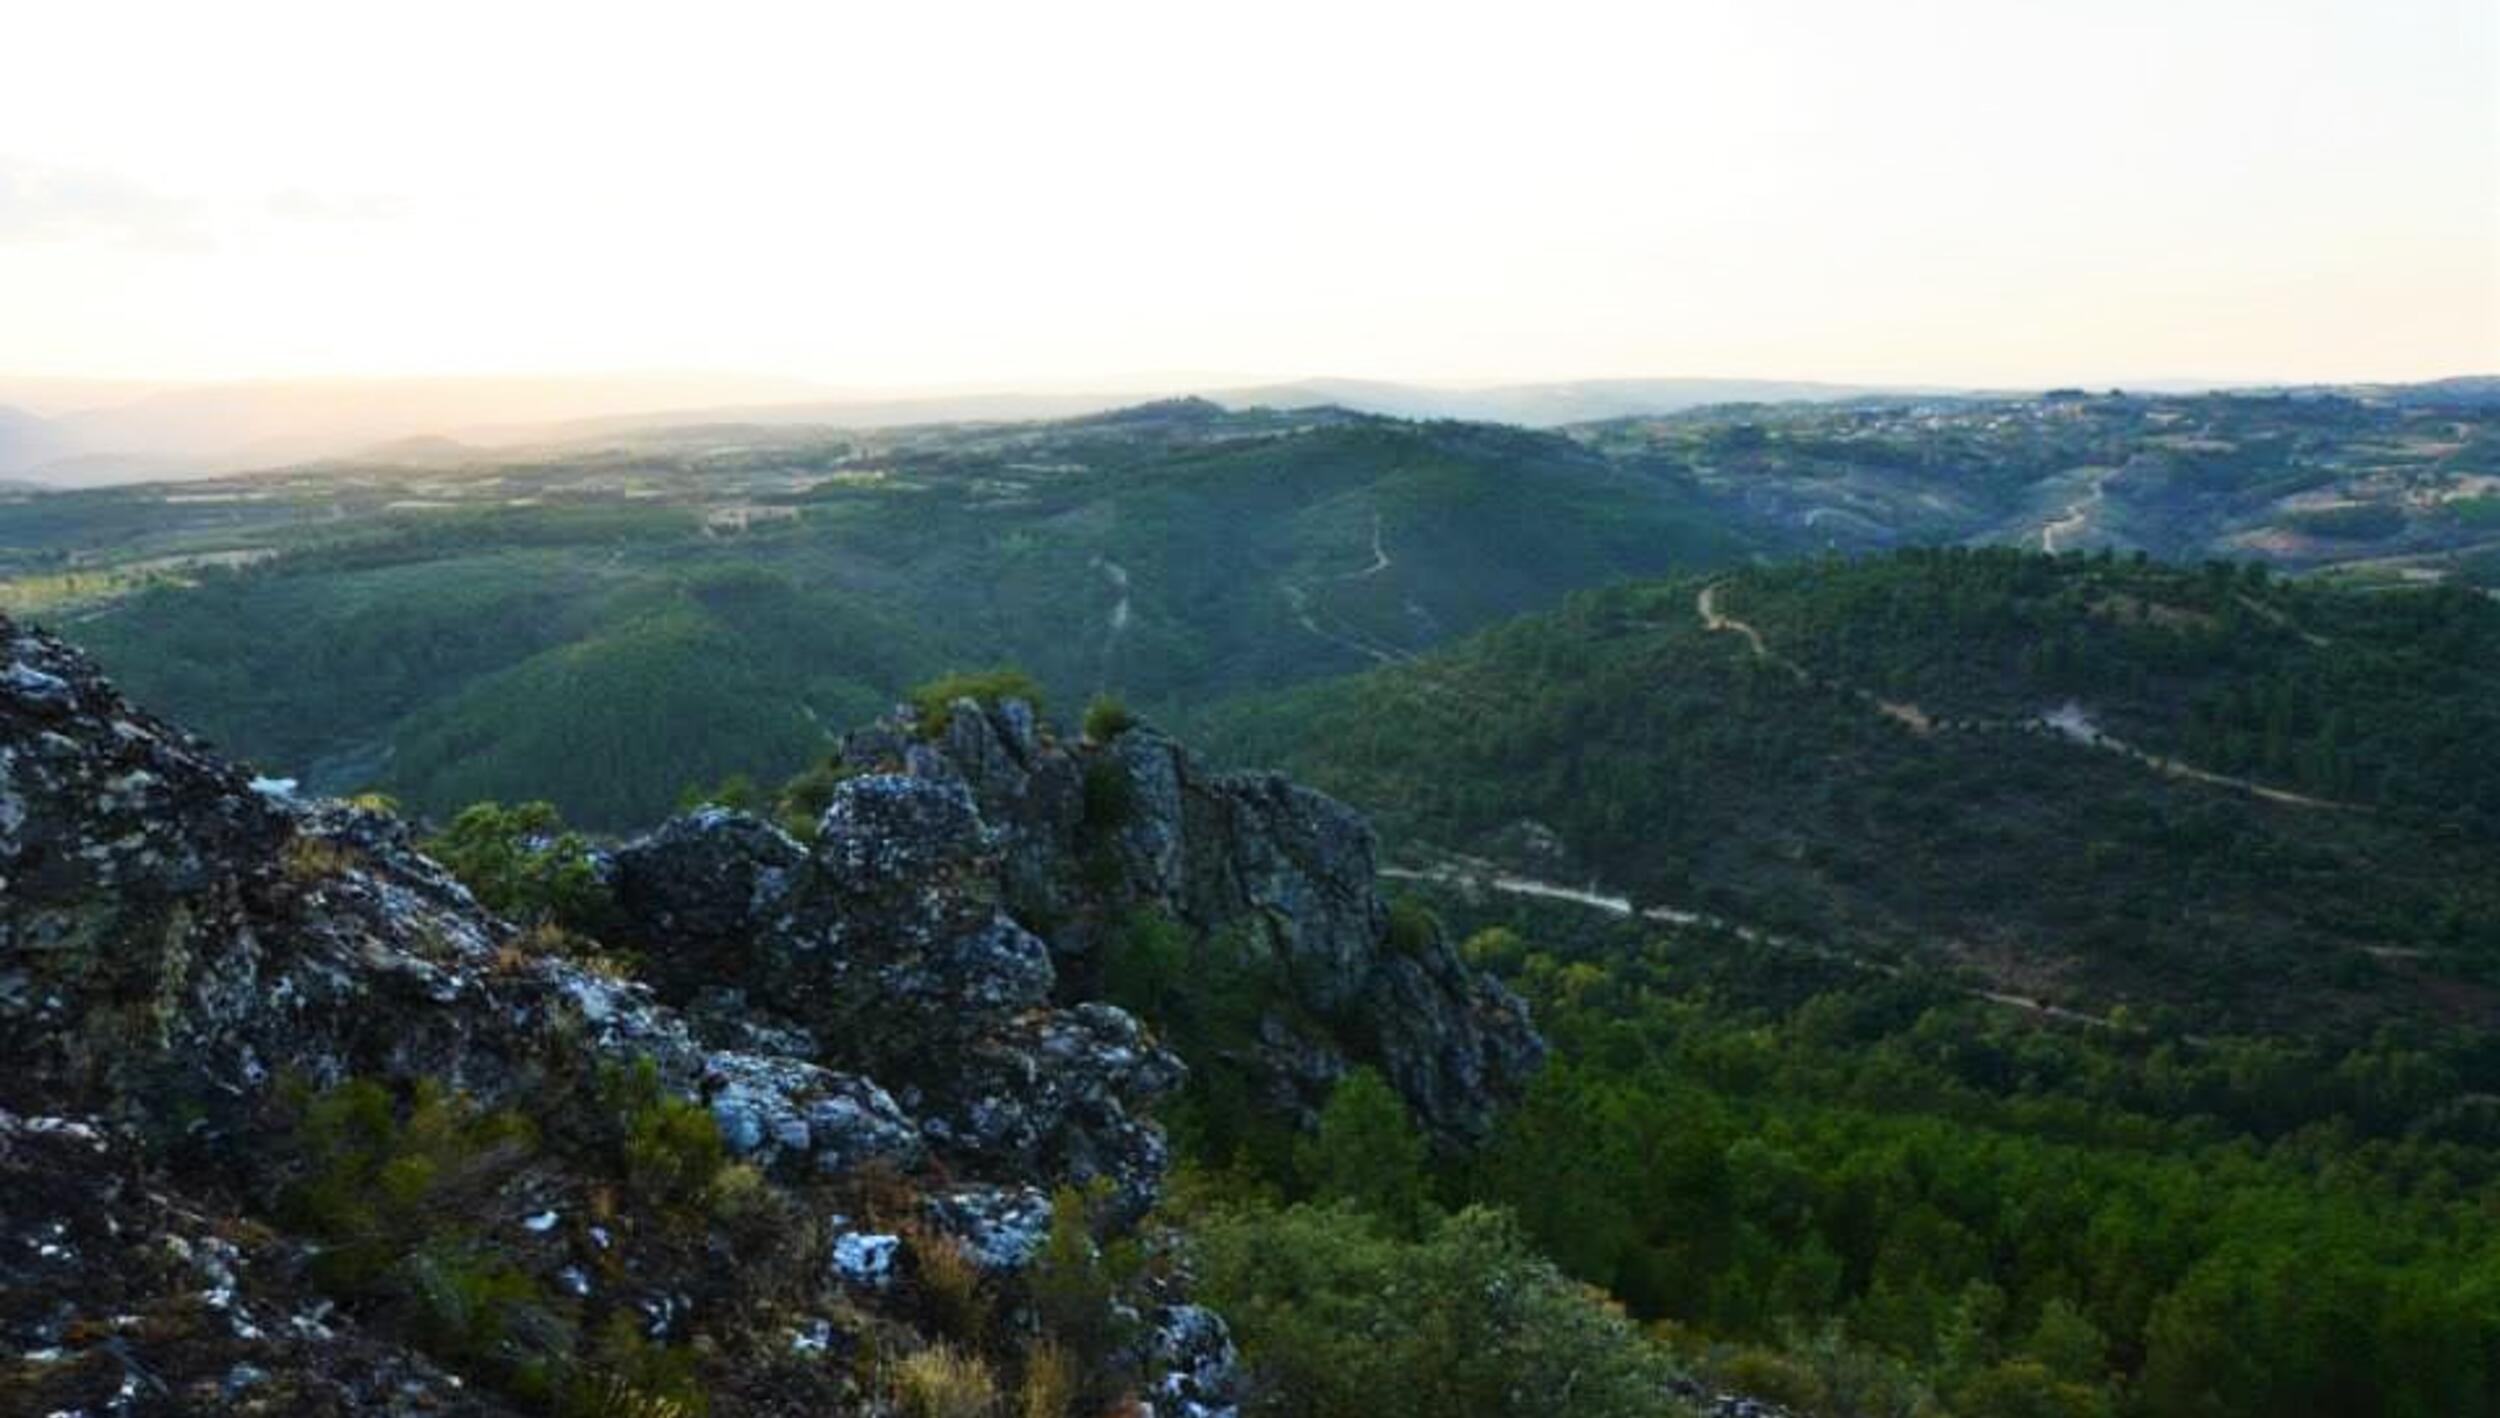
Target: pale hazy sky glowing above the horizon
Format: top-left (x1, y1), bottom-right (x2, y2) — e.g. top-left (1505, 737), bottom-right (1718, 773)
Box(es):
top-left (0, 0), bottom-right (2500, 388)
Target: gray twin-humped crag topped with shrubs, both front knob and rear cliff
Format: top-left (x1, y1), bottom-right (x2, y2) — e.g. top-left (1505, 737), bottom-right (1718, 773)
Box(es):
top-left (615, 700), bottom-right (1545, 1150)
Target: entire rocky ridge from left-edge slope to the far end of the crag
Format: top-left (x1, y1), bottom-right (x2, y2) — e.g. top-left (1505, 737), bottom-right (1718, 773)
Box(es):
top-left (0, 620), bottom-right (1540, 1415)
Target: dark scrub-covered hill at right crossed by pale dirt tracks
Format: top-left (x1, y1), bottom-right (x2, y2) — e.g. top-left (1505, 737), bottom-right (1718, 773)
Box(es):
top-left (1210, 550), bottom-right (2500, 1028)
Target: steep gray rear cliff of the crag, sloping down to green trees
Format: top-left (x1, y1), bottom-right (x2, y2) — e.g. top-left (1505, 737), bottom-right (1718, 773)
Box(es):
top-left (845, 700), bottom-right (1545, 1140)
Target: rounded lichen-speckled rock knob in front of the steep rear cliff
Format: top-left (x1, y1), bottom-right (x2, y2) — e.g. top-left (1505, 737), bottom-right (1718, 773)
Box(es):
top-left (613, 775), bottom-right (1183, 1215)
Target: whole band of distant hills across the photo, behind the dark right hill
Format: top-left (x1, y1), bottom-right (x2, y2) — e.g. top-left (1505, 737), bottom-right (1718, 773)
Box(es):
top-left (0, 388), bottom-right (2500, 825)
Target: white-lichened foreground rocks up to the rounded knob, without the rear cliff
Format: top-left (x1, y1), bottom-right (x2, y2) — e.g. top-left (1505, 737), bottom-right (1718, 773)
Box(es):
top-left (0, 620), bottom-right (1233, 1415)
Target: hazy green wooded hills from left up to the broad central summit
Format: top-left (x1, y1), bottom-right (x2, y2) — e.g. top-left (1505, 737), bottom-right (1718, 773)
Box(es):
top-left (29, 403), bottom-right (1748, 828)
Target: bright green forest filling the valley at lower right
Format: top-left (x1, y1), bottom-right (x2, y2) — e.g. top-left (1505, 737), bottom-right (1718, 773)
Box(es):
top-left (1350, 895), bottom-right (2500, 1418)
